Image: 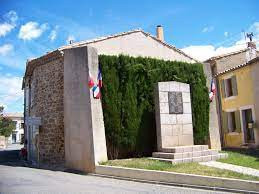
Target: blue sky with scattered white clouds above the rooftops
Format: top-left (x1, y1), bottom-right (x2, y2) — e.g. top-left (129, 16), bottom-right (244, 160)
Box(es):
top-left (0, 0), bottom-right (259, 112)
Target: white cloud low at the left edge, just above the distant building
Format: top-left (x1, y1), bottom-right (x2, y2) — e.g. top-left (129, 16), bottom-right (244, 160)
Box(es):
top-left (0, 75), bottom-right (23, 111)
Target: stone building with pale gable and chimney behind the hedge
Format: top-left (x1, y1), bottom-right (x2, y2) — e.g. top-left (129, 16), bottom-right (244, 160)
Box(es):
top-left (23, 26), bottom-right (221, 167)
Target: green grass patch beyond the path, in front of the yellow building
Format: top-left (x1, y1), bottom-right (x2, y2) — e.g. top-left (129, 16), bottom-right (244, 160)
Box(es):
top-left (218, 150), bottom-right (259, 170)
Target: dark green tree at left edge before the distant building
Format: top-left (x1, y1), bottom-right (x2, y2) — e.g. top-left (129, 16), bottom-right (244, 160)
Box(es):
top-left (0, 106), bottom-right (15, 137)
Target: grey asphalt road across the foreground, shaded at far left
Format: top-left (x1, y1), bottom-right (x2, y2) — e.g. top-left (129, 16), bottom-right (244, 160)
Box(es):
top-left (0, 145), bottom-right (235, 194)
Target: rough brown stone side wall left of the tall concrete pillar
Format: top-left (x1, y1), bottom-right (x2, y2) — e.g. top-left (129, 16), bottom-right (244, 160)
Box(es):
top-left (30, 54), bottom-right (65, 163)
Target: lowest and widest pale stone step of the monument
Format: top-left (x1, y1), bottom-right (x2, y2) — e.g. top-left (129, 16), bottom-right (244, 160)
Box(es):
top-left (150, 153), bottom-right (228, 164)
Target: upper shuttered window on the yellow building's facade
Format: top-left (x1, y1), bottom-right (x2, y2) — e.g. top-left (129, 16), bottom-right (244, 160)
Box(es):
top-left (221, 76), bottom-right (237, 98)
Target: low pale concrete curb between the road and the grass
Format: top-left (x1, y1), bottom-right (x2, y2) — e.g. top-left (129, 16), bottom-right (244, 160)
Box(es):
top-left (95, 165), bottom-right (259, 193)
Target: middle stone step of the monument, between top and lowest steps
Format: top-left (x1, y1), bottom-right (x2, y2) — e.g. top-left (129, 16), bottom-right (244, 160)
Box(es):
top-left (152, 150), bottom-right (218, 159)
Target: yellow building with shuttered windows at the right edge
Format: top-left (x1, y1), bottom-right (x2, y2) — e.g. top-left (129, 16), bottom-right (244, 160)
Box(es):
top-left (216, 57), bottom-right (259, 147)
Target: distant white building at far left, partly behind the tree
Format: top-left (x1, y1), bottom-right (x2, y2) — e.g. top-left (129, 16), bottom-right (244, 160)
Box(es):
top-left (4, 113), bottom-right (24, 143)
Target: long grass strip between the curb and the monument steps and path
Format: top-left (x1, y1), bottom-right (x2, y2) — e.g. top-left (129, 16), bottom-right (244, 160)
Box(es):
top-left (101, 158), bottom-right (259, 181)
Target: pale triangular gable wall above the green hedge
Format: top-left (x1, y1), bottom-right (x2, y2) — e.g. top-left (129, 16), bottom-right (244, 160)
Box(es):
top-left (88, 32), bottom-right (195, 63)
